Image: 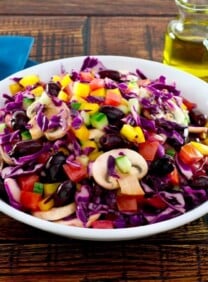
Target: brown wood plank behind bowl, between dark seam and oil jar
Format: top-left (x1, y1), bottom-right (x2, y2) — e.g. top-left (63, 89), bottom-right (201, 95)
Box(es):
top-left (88, 17), bottom-right (171, 61)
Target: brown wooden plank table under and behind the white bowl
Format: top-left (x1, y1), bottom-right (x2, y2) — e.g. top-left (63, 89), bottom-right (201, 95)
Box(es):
top-left (0, 0), bottom-right (208, 282)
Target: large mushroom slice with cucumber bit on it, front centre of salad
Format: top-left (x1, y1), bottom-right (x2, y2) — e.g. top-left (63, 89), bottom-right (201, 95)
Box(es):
top-left (92, 149), bottom-right (148, 195)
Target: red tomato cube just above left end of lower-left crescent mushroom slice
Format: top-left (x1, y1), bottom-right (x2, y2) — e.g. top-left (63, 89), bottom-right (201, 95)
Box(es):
top-left (20, 191), bottom-right (41, 211)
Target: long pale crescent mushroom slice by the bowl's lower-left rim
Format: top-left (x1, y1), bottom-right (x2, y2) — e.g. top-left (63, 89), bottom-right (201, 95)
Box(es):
top-left (33, 203), bottom-right (76, 221)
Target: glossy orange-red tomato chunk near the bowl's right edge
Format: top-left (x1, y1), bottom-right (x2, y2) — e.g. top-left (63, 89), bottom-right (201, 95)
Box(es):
top-left (178, 143), bottom-right (203, 165)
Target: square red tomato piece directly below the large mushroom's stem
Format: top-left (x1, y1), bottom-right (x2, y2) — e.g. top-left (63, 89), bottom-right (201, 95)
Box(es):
top-left (117, 194), bottom-right (138, 212)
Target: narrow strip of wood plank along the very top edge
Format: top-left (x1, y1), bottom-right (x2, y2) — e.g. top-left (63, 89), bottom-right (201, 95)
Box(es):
top-left (0, 0), bottom-right (177, 16)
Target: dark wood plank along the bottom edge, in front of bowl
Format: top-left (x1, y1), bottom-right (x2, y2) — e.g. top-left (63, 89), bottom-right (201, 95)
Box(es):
top-left (0, 241), bottom-right (208, 282)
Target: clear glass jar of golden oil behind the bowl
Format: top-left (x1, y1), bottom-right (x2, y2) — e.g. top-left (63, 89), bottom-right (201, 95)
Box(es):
top-left (163, 0), bottom-right (208, 81)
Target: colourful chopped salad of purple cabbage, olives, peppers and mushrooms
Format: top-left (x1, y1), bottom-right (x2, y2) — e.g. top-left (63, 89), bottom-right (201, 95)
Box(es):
top-left (0, 57), bottom-right (208, 228)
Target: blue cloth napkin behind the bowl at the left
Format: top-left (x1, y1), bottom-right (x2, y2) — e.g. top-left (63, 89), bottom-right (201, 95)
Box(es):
top-left (0, 35), bottom-right (37, 80)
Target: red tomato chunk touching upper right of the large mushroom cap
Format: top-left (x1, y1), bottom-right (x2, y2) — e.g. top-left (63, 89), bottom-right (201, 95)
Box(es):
top-left (139, 141), bottom-right (160, 161)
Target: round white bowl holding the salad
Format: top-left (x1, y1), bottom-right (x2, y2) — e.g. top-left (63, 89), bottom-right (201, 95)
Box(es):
top-left (0, 56), bottom-right (208, 241)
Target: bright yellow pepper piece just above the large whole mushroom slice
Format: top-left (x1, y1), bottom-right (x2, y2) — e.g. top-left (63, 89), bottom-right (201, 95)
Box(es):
top-left (120, 124), bottom-right (145, 143)
